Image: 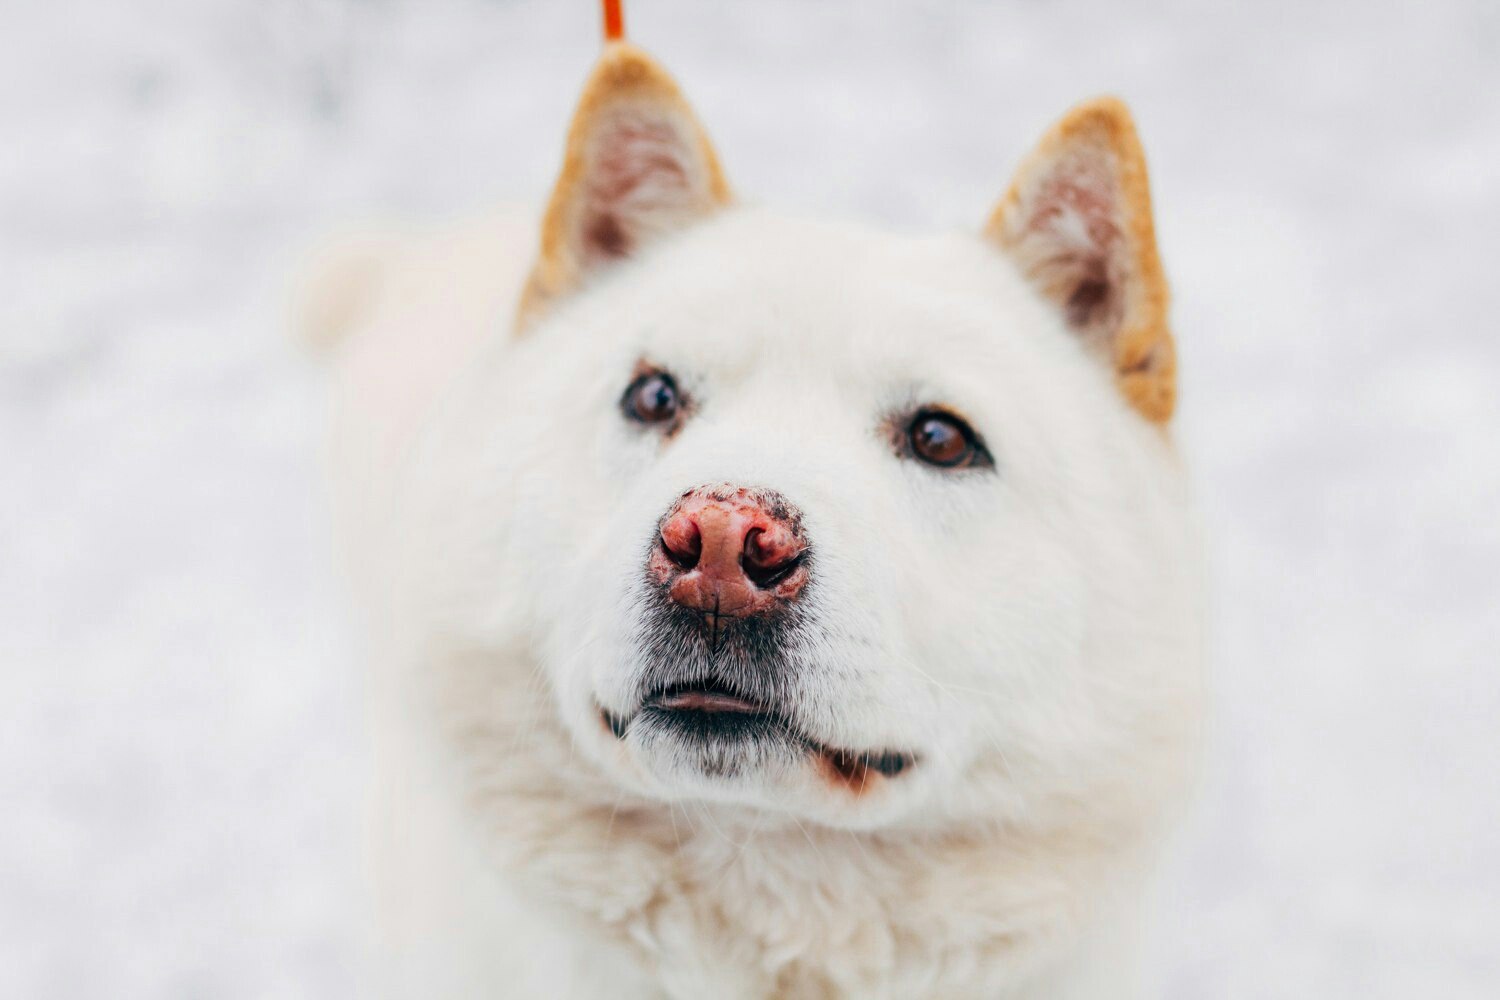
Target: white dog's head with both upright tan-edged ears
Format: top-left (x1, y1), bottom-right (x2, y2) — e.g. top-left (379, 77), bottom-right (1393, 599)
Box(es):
top-left (432, 45), bottom-right (1196, 828)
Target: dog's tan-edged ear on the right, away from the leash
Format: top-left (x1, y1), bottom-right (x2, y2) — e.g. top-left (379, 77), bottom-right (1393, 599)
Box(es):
top-left (986, 97), bottom-right (1178, 423)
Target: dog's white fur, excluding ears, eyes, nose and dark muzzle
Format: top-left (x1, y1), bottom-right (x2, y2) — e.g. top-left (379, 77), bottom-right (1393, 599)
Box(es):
top-left (316, 199), bottom-right (1200, 1000)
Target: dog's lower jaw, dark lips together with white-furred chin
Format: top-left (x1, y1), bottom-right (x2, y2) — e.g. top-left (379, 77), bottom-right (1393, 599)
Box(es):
top-left (600, 682), bottom-right (917, 807)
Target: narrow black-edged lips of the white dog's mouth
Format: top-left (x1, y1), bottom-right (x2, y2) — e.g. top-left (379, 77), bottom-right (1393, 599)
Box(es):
top-left (600, 682), bottom-right (917, 787)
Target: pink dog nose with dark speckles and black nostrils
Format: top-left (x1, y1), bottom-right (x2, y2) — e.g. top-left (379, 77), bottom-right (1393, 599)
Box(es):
top-left (650, 487), bottom-right (807, 618)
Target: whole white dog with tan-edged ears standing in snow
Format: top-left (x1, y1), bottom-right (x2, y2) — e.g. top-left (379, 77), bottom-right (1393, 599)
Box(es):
top-left (308, 37), bottom-right (1202, 1000)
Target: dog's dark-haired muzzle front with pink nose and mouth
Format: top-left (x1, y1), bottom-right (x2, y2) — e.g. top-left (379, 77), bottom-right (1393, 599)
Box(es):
top-left (602, 484), bottom-right (915, 792)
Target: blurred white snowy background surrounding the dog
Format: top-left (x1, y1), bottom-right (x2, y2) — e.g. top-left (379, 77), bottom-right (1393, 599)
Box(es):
top-left (0, 0), bottom-right (1500, 1000)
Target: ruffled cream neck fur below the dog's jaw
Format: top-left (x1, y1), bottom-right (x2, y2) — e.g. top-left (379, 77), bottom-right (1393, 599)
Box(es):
top-left (417, 644), bottom-right (1140, 1000)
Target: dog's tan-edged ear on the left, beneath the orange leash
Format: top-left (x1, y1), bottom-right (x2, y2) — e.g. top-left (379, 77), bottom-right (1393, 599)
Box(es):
top-left (516, 42), bottom-right (731, 328)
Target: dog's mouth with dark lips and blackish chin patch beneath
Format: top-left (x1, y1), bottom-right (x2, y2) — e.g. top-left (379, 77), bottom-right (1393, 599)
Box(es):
top-left (600, 681), bottom-right (917, 795)
